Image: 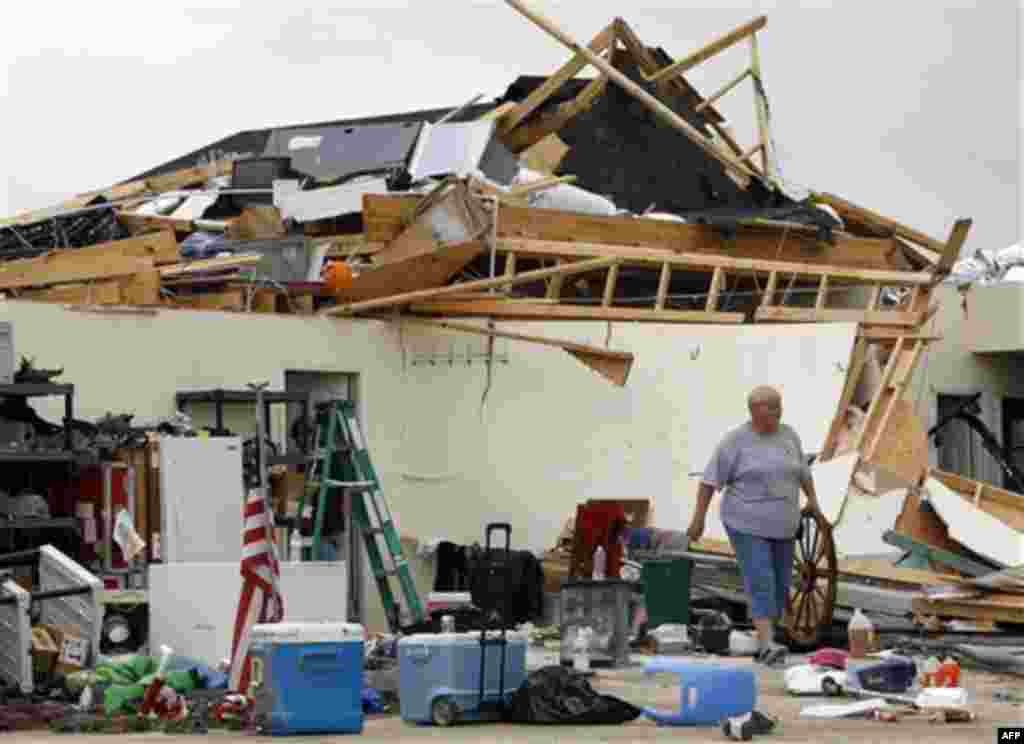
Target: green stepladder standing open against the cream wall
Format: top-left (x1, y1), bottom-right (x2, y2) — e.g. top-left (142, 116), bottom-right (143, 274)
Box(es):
top-left (298, 400), bottom-right (426, 632)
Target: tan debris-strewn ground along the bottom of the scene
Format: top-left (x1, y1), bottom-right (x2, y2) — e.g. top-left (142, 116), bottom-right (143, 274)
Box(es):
top-left (8, 659), bottom-right (1024, 744)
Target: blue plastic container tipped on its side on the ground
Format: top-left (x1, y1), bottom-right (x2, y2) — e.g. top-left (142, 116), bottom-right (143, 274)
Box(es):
top-left (643, 656), bottom-right (758, 726)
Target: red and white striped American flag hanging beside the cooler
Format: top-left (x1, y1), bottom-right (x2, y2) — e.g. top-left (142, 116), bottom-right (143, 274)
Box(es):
top-left (228, 488), bottom-right (285, 694)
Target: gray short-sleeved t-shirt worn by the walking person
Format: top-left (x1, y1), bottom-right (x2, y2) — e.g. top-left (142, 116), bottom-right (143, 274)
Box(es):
top-left (701, 423), bottom-right (810, 539)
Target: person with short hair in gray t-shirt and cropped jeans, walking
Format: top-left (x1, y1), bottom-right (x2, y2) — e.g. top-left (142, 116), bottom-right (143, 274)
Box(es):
top-left (687, 387), bottom-right (818, 664)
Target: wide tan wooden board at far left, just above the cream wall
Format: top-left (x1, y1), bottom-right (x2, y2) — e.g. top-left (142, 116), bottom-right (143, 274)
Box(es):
top-left (0, 232), bottom-right (169, 290)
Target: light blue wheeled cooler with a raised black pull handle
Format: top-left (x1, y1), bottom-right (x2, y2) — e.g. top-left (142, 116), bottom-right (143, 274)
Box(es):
top-left (398, 631), bottom-right (526, 725)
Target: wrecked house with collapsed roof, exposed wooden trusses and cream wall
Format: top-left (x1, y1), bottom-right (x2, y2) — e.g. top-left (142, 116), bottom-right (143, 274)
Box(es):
top-left (0, 2), bottom-right (1024, 704)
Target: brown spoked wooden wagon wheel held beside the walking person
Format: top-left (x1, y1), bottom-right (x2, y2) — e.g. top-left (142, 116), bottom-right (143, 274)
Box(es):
top-left (782, 511), bottom-right (839, 646)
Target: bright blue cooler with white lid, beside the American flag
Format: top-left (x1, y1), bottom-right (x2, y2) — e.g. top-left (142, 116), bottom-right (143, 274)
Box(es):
top-left (249, 622), bottom-right (364, 736)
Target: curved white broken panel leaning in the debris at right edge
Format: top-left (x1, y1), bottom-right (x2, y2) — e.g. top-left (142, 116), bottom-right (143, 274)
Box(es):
top-left (925, 478), bottom-right (1024, 566)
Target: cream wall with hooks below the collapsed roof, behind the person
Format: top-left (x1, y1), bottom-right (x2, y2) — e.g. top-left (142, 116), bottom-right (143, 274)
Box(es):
top-left (0, 301), bottom-right (853, 550)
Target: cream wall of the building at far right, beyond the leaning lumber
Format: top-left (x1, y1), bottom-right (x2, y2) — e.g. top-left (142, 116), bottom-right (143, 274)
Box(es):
top-left (909, 285), bottom-right (1024, 485)
